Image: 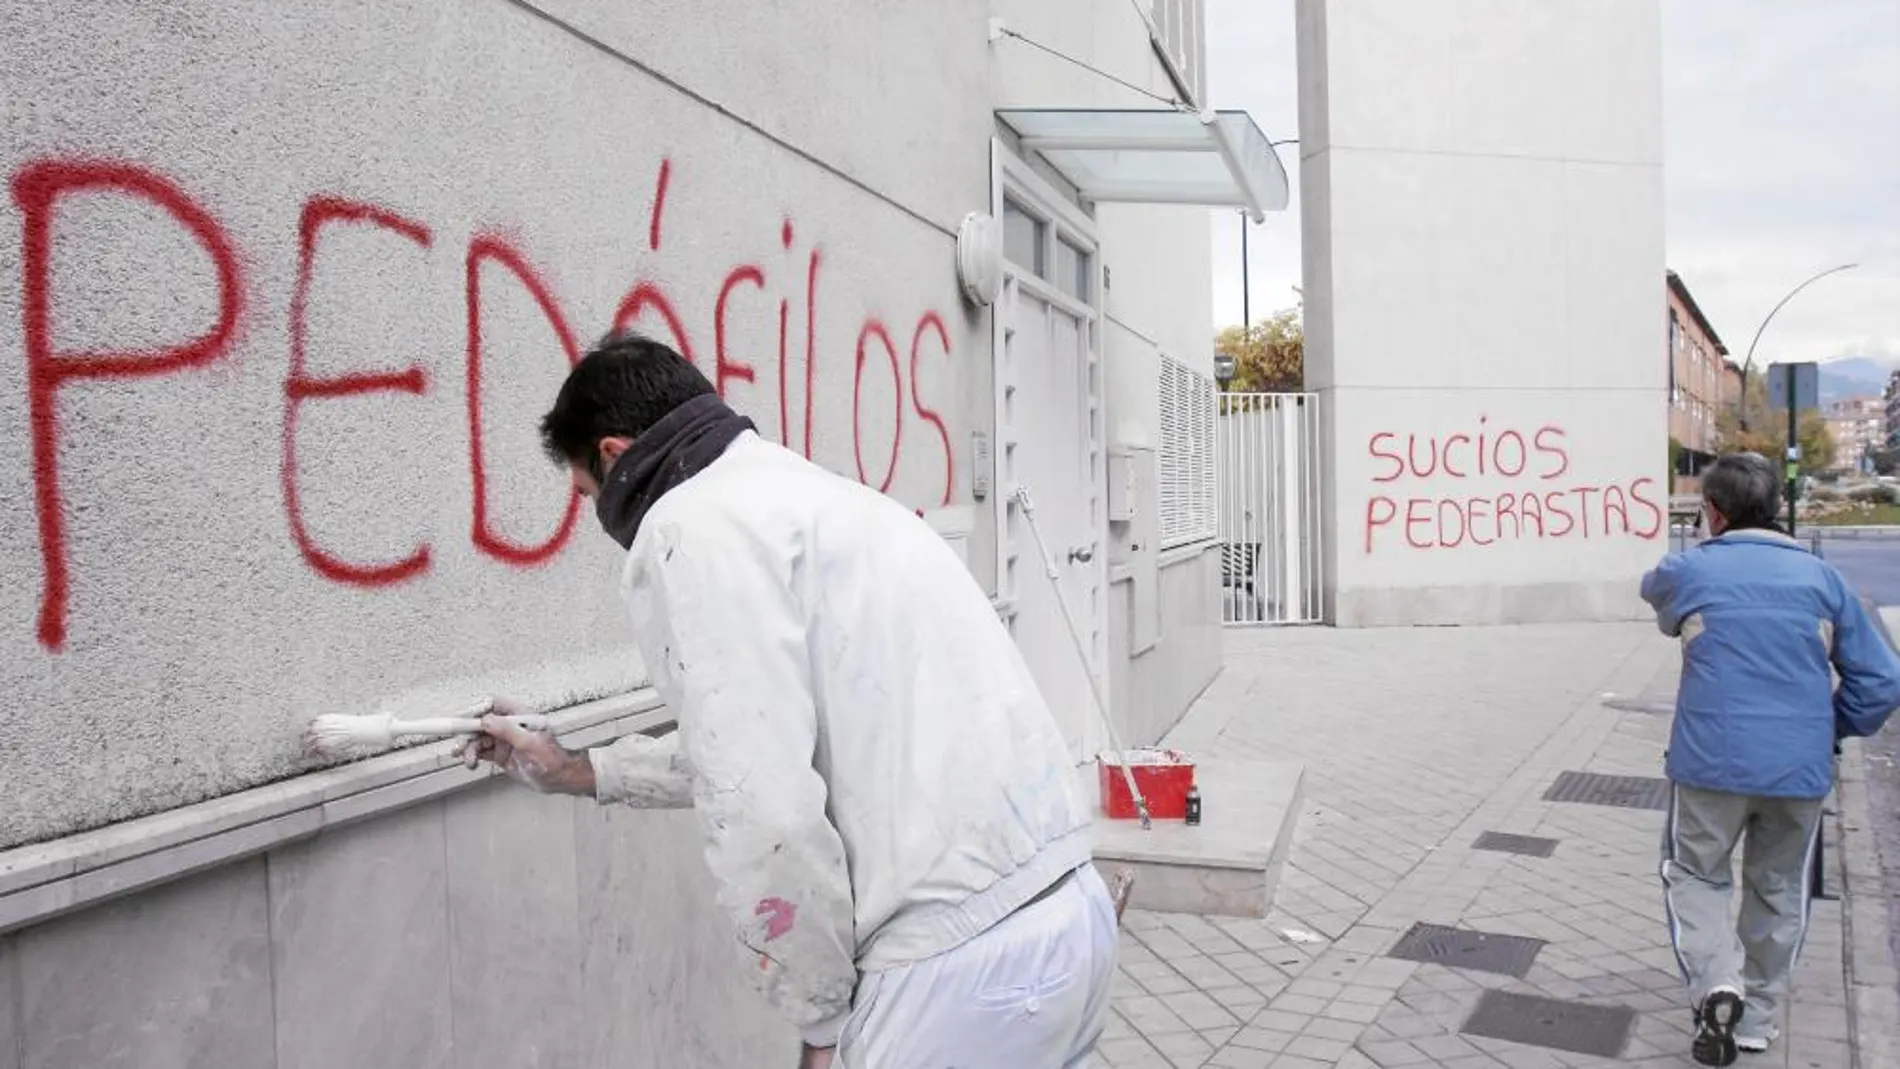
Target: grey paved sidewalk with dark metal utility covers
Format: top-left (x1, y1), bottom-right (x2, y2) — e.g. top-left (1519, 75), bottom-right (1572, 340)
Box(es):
top-left (1098, 625), bottom-right (1900, 1069)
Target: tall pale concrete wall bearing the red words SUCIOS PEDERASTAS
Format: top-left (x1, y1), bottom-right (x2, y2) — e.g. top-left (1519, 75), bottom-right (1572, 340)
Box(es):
top-left (1298, 0), bottom-right (1668, 625)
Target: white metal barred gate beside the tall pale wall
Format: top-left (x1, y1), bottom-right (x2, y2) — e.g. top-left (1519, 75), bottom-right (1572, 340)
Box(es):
top-left (1214, 393), bottom-right (1322, 627)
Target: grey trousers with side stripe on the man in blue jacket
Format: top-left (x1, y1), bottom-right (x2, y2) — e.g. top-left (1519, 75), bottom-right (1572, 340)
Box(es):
top-left (1663, 784), bottom-right (1822, 1035)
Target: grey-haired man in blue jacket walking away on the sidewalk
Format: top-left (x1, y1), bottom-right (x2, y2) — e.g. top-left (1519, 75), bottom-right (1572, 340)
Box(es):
top-left (1644, 454), bottom-right (1900, 1065)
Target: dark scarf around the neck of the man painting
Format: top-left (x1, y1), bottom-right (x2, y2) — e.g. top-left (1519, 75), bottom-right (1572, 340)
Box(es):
top-left (595, 393), bottom-right (758, 549)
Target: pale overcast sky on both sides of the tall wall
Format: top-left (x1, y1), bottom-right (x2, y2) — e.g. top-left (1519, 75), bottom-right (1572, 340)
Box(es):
top-left (1207, 0), bottom-right (1900, 363)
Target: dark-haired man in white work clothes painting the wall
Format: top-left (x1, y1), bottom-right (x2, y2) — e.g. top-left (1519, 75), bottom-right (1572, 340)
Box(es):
top-left (466, 334), bottom-right (1115, 1069)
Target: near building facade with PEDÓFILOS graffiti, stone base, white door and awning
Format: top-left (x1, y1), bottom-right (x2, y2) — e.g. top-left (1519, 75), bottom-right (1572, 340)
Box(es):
top-left (0, 0), bottom-right (1286, 1069)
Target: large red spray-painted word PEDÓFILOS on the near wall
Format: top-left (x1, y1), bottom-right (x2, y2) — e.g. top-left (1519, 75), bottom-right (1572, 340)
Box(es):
top-left (10, 159), bottom-right (956, 651)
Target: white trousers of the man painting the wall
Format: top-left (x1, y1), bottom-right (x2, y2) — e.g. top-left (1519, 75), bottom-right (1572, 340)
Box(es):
top-left (838, 864), bottom-right (1115, 1069)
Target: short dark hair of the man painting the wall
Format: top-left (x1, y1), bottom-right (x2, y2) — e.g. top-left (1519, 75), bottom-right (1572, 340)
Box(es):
top-left (542, 330), bottom-right (713, 465)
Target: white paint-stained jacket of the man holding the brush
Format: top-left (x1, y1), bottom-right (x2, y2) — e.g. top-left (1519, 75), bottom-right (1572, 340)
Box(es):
top-left (593, 433), bottom-right (1089, 1046)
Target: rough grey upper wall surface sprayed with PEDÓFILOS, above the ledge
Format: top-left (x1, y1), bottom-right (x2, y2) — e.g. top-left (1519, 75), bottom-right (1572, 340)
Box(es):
top-left (0, 0), bottom-right (990, 847)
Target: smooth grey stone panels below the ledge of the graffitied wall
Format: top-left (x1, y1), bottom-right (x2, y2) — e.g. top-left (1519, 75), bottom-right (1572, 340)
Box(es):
top-left (0, 782), bottom-right (798, 1069)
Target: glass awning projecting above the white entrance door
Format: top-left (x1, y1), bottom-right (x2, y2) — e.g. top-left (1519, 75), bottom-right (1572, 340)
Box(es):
top-left (996, 108), bottom-right (1288, 222)
